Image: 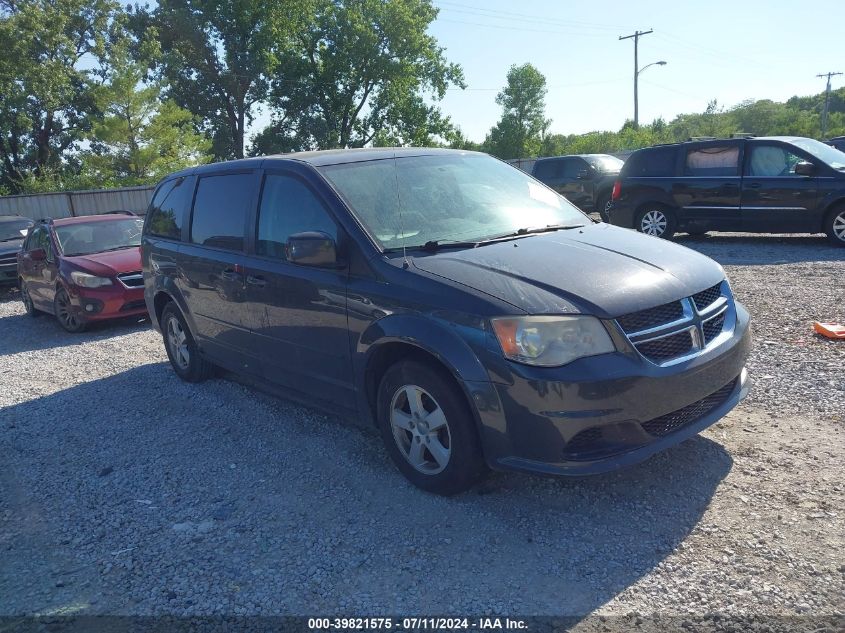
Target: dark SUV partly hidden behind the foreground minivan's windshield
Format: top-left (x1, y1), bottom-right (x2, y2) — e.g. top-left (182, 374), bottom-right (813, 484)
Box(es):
top-left (531, 154), bottom-right (624, 222)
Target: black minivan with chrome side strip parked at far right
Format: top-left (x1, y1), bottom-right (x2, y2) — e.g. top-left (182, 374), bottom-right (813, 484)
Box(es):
top-left (609, 136), bottom-right (845, 246)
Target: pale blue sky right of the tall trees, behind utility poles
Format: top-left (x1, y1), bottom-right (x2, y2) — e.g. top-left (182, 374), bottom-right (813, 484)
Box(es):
top-left (429, 0), bottom-right (845, 141)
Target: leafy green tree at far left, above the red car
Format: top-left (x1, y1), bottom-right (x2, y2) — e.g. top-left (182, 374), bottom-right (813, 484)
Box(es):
top-left (0, 0), bottom-right (118, 192)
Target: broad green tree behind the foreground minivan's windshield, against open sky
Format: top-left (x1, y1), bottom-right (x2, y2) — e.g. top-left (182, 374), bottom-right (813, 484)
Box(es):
top-left (253, 0), bottom-right (464, 154)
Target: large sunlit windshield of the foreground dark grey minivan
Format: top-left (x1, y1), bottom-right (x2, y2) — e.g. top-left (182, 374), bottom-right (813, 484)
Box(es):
top-left (320, 154), bottom-right (590, 250)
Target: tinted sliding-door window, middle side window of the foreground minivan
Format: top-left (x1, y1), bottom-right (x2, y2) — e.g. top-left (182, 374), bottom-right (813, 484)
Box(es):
top-left (191, 174), bottom-right (255, 251)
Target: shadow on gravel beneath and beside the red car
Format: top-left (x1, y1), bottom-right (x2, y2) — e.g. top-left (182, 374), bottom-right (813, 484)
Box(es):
top-left (0, 297), bottom-right (150, 356)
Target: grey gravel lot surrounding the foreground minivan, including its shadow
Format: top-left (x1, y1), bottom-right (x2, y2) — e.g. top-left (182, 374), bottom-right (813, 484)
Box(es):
top-left (0, 235), bottom-right (845, 631)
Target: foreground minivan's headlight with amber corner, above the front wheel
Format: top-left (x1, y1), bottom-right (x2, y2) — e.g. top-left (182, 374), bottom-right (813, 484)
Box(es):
top-left (491, 316), bottom-right (616, 367)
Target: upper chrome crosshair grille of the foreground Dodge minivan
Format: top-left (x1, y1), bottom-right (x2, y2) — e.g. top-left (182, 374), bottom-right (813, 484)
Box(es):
top-left (616, 282), bottom-right (736, 365)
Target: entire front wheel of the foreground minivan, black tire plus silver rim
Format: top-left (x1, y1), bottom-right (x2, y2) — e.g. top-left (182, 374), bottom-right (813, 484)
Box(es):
top-left (377, 361), bottom-right (486, 496)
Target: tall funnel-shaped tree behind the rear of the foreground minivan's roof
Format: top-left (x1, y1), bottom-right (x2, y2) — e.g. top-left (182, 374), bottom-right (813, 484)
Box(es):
top-left (134, 0), bottom-right (312, 158)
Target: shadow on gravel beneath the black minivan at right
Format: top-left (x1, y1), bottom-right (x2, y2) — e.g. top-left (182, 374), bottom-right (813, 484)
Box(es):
top-left (675, 233), bottom-right (845, 266)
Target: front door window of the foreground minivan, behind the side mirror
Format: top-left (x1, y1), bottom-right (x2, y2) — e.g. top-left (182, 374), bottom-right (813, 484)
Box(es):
top-left (256, 174), bottom-right (337, 259)
